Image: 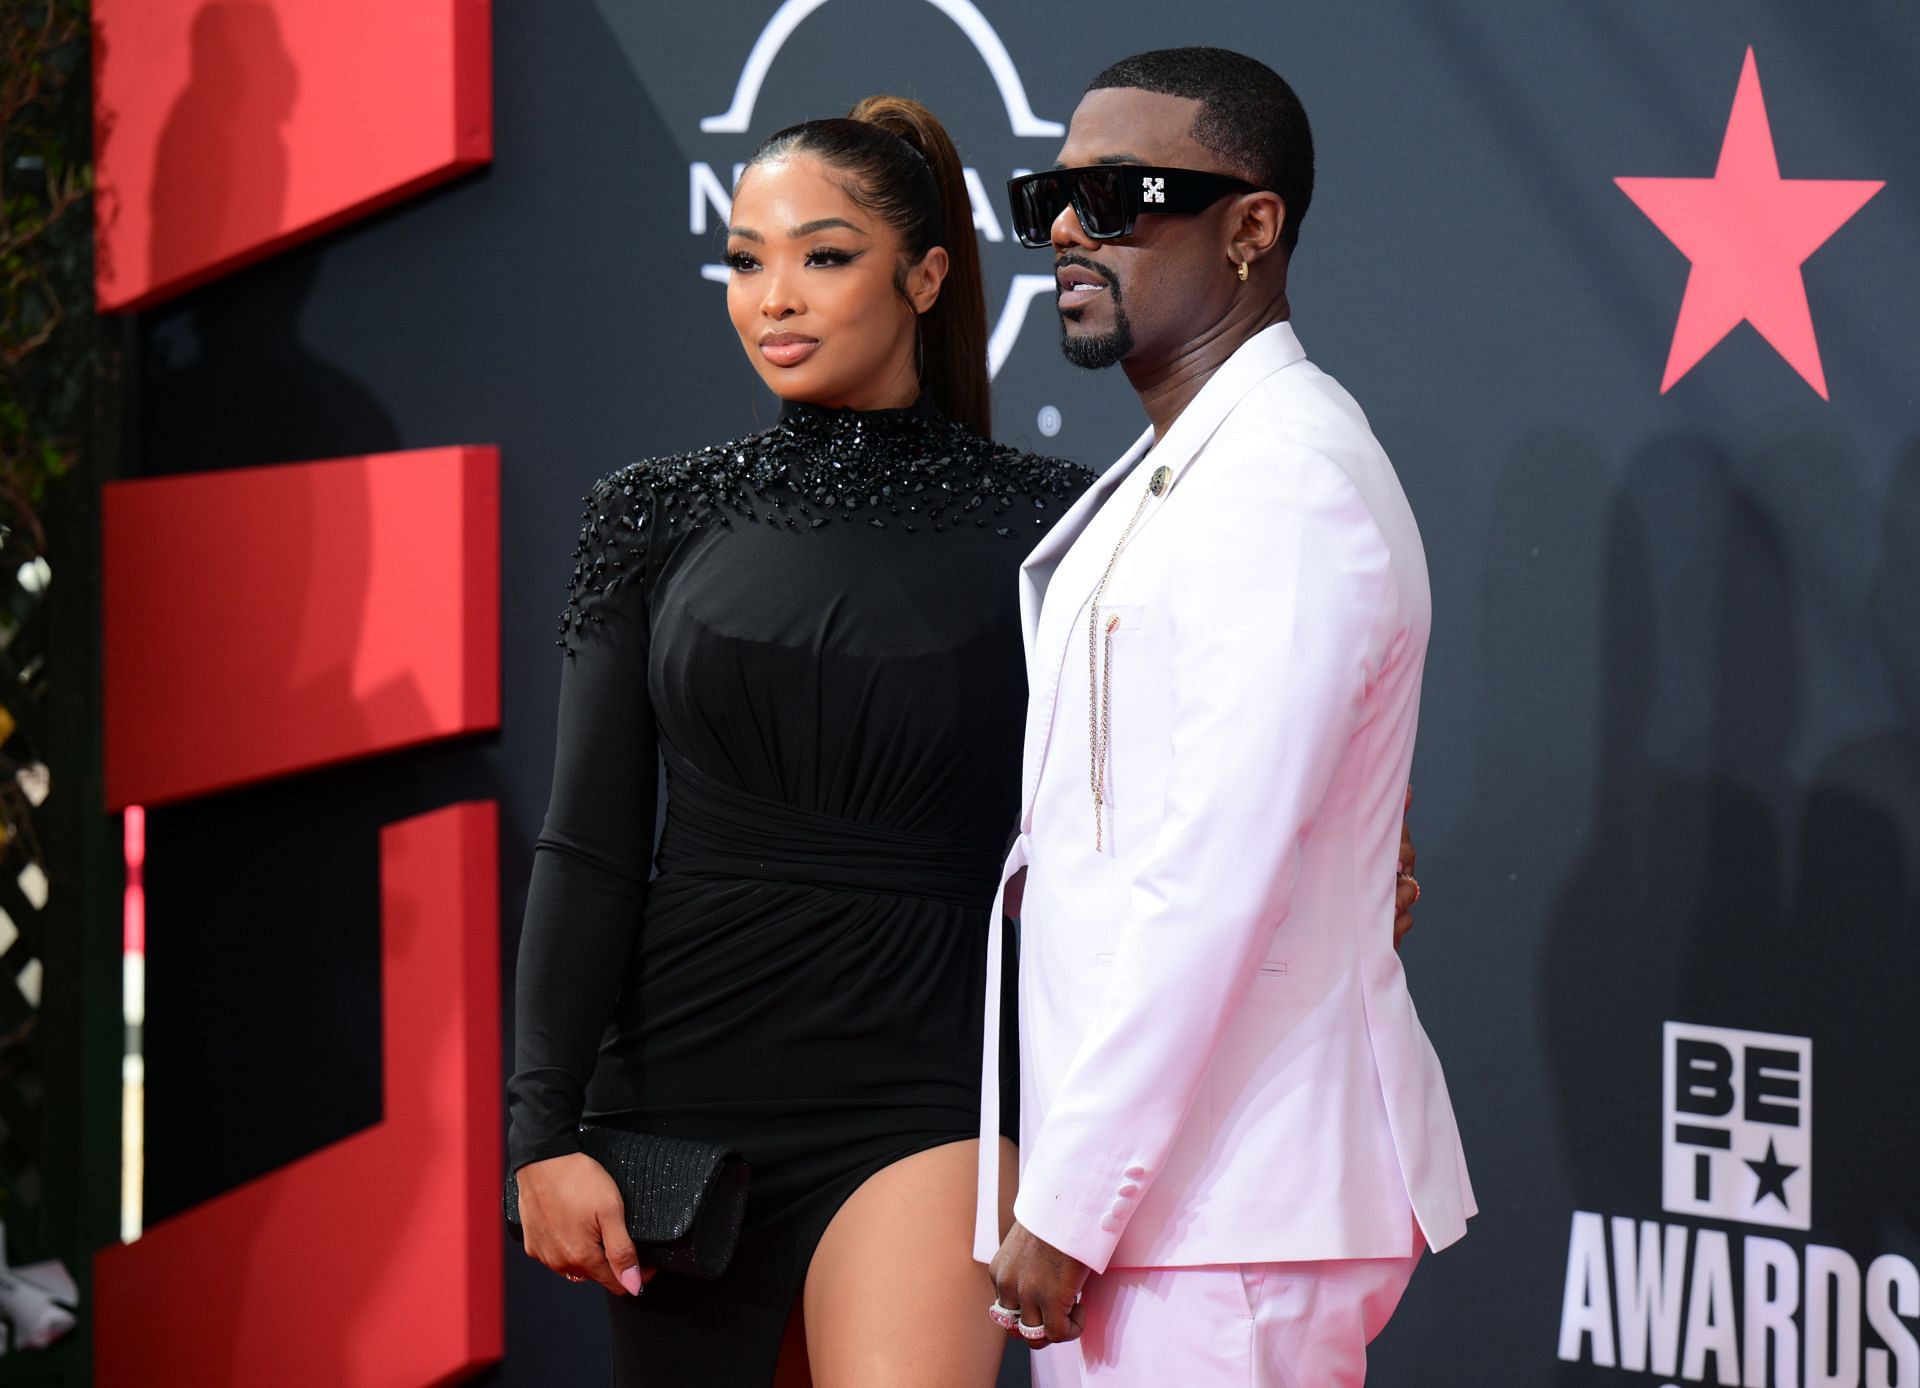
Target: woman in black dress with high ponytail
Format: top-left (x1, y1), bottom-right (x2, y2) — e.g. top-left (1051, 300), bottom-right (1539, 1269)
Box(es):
top-left (509, 98), bottom-right (1428, 1388)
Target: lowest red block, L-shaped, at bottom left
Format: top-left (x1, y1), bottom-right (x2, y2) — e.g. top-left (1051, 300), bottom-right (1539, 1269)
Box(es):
top-left (94, 802), bottom-right (505, 1388)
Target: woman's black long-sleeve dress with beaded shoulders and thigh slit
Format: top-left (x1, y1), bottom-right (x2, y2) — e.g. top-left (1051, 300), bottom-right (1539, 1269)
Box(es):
top-left (509, 401), bottom-right (1091, 1388)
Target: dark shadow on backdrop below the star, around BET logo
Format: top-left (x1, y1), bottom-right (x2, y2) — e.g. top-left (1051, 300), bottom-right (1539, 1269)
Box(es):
top-left (1542, 436), bottom-right (1920, 1388)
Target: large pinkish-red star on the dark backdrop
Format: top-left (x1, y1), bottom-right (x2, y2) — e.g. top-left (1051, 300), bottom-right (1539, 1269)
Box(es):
top-left (1615, 48), bottom-right (1885, 399)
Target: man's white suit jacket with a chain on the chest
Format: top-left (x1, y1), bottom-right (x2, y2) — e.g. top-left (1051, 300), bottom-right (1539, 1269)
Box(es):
top-left (975, 323), bottom-right (1475, 1271)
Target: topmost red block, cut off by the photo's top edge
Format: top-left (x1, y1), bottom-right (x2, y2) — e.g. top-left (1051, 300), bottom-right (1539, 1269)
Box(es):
top-left (92, 0), bottom-right (493, 309)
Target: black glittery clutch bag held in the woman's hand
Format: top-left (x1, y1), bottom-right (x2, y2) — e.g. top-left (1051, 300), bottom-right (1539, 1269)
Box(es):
top-left (505, 1123), bottom-right (747, 1277)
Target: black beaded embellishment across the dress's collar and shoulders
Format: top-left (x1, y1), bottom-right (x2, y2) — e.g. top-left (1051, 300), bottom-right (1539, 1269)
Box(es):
top-left (559, 405), bottom-right (1092, 653)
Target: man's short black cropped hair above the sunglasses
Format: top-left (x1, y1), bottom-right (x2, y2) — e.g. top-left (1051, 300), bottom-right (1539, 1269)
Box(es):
top-left (1087, 48), bottom-right (1313, 255)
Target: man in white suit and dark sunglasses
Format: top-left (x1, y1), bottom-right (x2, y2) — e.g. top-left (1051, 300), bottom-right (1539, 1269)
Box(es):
top-left (975, 48), bottom-right (1475, 1388)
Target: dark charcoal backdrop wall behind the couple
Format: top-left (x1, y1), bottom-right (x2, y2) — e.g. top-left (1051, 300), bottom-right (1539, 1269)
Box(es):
top-left (132, 0), bottom-right (1920, 1386)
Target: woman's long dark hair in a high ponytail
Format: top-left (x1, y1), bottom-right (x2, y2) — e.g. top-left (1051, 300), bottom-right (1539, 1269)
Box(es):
top-left (749, 96), bottom-right (993, 434)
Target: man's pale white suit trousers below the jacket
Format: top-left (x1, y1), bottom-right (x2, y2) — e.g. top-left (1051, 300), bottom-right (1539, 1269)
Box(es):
top-left (1033, 1250), bottom-right (1419, 1388)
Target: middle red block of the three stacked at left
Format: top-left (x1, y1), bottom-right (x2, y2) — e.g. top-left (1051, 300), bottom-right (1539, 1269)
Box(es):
top-left (104, 447), bottom-right (499, 808)
